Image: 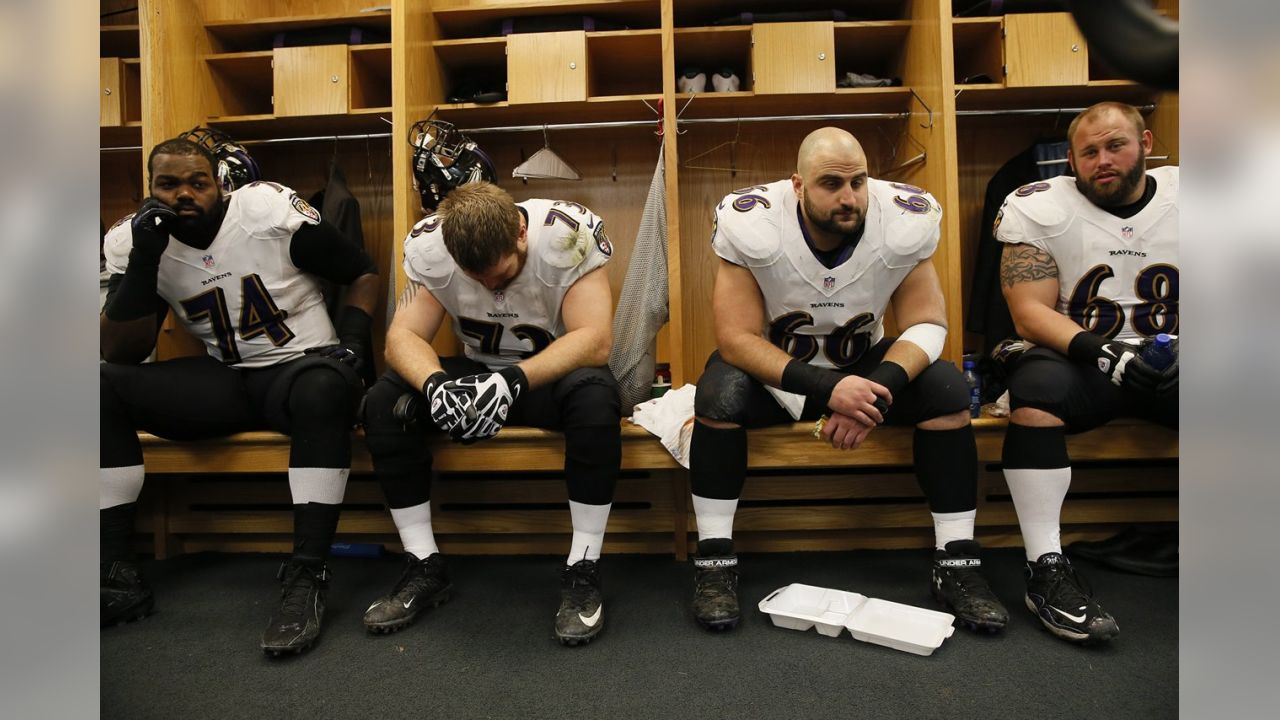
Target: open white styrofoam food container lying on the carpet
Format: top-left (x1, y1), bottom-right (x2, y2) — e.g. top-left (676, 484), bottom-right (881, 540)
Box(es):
top-left (759, 583), bottom-right (955, 655)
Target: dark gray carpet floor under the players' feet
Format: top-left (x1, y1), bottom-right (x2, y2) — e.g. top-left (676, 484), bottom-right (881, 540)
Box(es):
top-left (101, 550), bottom-right (1178, 720)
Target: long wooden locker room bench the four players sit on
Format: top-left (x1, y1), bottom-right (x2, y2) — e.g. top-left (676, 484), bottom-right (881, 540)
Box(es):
top-left (138, 418), bottom-right (1178, 560)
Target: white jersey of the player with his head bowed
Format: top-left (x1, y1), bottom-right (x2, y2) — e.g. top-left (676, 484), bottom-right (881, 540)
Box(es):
top-left (404, 200), bottom-right (613, 368)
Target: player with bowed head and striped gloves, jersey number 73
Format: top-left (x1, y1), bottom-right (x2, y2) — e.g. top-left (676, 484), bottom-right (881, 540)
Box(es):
top-left (365, 182), bottom-right (622, 644)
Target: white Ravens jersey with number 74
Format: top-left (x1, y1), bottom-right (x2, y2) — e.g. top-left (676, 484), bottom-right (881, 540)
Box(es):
top-left (104, 182), bottom-right (338, 368)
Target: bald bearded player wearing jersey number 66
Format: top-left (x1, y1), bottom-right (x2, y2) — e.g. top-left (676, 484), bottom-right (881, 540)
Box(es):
top-left (690, 127), bottom-right (1009, 632)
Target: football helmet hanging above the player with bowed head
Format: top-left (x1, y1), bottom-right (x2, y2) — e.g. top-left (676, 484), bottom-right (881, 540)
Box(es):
top-left (408, 119), bottom-right (497, 213)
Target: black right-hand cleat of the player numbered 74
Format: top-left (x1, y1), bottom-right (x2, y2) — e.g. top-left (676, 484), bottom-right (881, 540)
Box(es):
top-left (262, 557), bottom-right (329, 657)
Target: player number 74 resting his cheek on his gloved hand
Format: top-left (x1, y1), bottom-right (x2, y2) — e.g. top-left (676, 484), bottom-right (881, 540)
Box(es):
top-left (100, 138), bottom-right (378, 656)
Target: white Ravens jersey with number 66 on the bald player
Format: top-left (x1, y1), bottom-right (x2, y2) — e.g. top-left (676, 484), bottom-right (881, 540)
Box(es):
top-left (712, 179), bottom-right (942, 368)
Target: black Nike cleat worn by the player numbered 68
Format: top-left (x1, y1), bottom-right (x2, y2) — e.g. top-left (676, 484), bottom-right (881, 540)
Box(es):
top-left (1027, 552), bottom-right (1120, 644)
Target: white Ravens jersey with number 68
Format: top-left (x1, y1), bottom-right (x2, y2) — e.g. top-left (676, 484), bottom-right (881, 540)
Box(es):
top-left (996, 167), bottom-right (1178, 341)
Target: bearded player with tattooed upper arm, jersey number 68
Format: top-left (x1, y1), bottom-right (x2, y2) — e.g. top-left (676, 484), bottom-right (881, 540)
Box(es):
top-left (996, 102), bottom-right (1178, 642)
